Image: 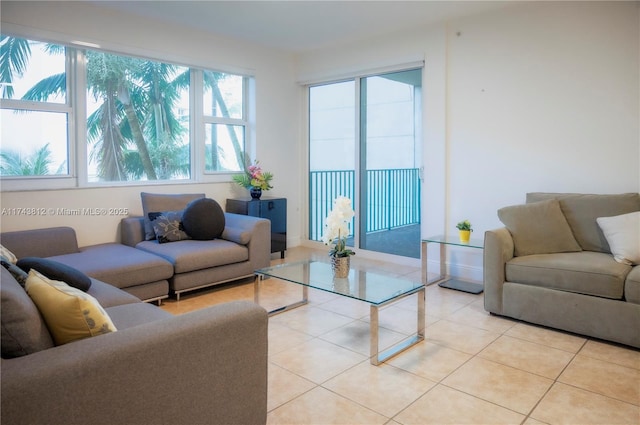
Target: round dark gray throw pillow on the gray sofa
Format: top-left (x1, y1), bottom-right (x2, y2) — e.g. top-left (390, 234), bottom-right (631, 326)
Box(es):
top-left (182, 198), bottom-right (225, 241)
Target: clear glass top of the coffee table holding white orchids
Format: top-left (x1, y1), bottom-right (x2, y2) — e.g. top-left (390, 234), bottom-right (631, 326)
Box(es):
top-left (255, 261), bottom-right (423, 305)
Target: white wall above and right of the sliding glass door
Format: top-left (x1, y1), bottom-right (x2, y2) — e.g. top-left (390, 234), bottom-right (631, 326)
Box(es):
top-left (298, 2), bottom-right (640, 279)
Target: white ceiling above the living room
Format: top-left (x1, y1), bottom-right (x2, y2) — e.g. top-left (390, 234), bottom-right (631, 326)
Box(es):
top-left (92, 0), bottom-right (509, 52)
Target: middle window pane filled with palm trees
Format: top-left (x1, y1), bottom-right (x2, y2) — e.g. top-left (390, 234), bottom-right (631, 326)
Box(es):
top-left (86, 50), bottom-right (191, 181)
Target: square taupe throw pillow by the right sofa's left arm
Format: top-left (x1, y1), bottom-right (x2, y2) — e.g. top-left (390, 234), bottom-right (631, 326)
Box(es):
top-left (498, 199), bottom-right (581, 256)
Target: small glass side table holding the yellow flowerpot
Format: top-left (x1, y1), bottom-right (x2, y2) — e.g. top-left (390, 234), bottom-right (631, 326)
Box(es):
top-left (421, 235), bottom-right (484, 294)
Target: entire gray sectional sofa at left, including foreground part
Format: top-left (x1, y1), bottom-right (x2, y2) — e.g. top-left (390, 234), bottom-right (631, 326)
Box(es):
top-left (0, 194), bottom-right (271, 425)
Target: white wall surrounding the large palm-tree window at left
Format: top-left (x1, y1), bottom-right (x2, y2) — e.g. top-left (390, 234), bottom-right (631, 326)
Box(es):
top-left (0, 1), bottom-right (302, 246)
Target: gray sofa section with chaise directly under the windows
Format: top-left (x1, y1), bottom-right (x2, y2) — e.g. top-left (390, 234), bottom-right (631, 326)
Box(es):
top-left (0, 193), bottom-right (271, 302)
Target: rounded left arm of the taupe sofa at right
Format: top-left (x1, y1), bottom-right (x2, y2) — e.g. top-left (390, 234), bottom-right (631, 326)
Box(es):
top-left (483, 227), bottom-right (513, 314)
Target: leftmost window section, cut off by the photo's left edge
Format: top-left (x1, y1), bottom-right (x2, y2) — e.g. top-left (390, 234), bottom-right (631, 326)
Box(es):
top-left (0, 35), bottom-right (72, 177)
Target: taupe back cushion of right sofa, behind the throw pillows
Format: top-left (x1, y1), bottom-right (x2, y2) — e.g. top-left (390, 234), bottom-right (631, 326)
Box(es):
top-left (527, 192), bottom-right (640, 252)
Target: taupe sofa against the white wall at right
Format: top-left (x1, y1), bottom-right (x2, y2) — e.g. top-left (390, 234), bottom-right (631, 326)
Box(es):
top-left (484, 193), bottom-right (640, 348)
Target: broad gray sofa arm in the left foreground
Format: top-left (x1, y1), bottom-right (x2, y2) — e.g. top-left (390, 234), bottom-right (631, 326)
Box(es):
top-left (1, 301), bottom-right (267, 425)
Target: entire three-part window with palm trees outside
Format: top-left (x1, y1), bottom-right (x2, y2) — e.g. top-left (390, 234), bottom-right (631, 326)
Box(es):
top-left (0, 35), bottom-right (249, 185)
